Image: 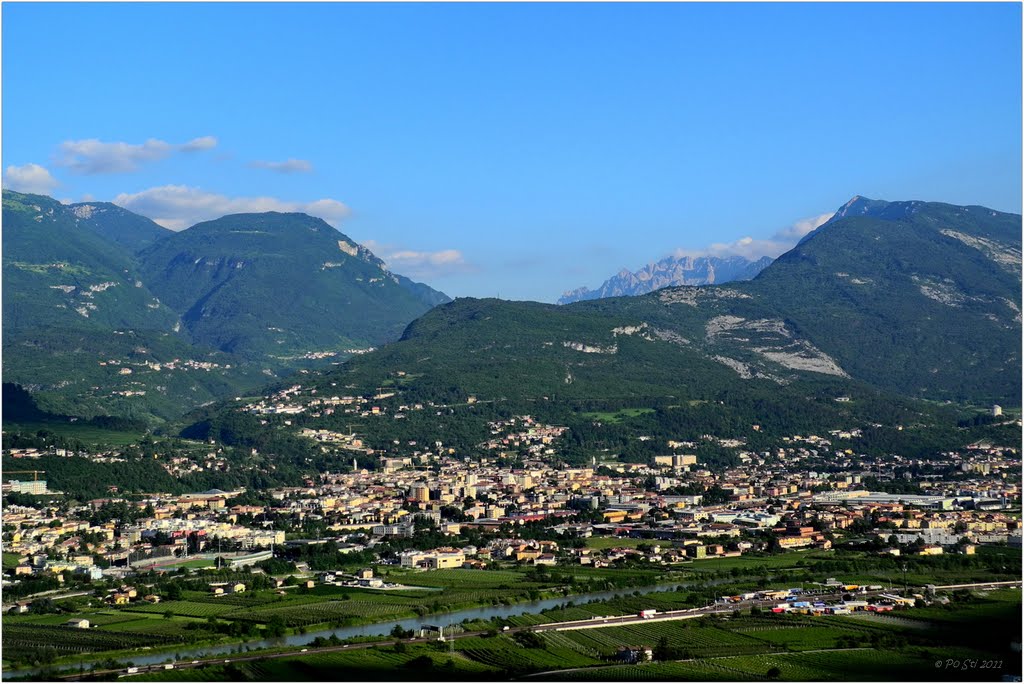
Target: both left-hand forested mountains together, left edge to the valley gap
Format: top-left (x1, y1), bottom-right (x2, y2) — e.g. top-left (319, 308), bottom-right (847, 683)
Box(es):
top-left (3, 190), bottom-right (449, 419)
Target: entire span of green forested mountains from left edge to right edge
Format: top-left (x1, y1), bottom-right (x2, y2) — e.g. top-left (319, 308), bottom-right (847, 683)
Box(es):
top-left (3, 191), bottom-right (1021, 428)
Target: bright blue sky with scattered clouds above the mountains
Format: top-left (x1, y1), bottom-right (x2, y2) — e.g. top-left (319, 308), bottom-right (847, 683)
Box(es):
top-left (2, 3), bottom-right (1022, 301)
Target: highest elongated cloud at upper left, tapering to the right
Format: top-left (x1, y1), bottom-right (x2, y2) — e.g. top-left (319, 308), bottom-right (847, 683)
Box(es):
top-left (54, 135), bottom-right (217, 175)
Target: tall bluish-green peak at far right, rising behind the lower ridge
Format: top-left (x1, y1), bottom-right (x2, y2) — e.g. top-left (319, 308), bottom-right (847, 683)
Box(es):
top-left (750, 198), bottom-right (1021, 405)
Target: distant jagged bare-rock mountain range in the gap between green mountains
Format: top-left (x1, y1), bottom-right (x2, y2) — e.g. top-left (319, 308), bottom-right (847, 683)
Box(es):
top-left (558, 256), bottom-right (772, 304)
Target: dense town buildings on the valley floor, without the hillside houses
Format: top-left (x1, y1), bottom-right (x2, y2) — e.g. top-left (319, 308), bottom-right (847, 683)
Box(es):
top-left (4, 432), bottom-right (1021, 589)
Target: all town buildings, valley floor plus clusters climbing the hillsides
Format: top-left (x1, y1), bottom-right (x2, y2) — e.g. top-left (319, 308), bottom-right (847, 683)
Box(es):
top-left (4, 385), bottom-right (1021, 593)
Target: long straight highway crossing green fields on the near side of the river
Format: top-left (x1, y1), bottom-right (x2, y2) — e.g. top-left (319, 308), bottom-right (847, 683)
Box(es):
top-left (48, 580), bottom-right (1022, 681)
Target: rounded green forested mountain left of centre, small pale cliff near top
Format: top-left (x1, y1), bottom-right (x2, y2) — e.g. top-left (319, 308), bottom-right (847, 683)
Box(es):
top-left (140, 212), bottom-right (446, 359)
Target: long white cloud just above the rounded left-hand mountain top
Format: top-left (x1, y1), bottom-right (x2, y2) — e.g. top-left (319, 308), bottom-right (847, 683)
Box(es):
top-left (114, 185), bottom-right (351, 230)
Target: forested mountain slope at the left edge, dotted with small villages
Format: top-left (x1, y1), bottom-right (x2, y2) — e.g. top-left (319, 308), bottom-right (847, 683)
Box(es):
top-left (3, 190), bottom-right (270, 420)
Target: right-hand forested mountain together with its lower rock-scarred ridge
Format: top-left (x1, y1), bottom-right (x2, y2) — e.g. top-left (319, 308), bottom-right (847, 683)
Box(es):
top-left (321, 193), bottom-right (1021, 405)
